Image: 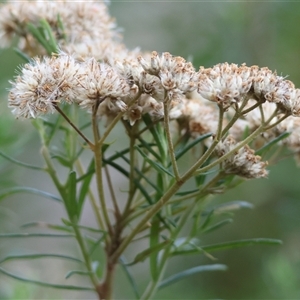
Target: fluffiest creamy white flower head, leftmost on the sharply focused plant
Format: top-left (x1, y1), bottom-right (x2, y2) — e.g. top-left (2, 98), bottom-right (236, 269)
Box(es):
top-left (9, 55), bottom-right (79, 118)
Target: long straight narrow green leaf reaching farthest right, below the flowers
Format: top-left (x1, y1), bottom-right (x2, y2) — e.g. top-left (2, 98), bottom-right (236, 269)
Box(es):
top-left (173, 238), bottom-right (282, 255)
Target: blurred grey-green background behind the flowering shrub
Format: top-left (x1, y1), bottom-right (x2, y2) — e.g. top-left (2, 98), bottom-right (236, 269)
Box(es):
top-left (0, 1), bottom-right (300, 299)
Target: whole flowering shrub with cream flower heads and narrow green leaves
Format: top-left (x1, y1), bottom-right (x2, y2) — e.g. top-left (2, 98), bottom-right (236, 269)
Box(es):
top-left (0, 1), bottom-right (300, 299)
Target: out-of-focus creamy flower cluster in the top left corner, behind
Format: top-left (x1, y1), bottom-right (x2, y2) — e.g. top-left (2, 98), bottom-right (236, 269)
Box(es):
top-left (0, 0), bottom-right (129, 60)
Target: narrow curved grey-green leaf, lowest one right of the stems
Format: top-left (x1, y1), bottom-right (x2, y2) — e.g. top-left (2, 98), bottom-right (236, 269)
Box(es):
top-left (158, 264), bottom-right (227, 289)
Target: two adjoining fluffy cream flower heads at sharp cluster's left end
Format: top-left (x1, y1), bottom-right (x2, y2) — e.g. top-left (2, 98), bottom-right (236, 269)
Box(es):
top-left (9, 54), bottom-right (130, 118)
